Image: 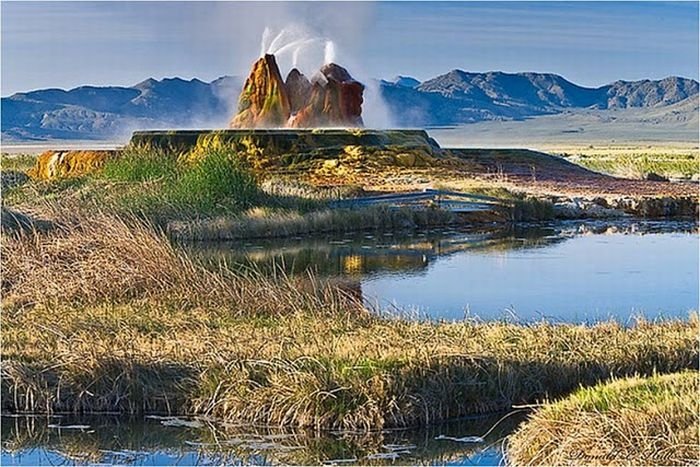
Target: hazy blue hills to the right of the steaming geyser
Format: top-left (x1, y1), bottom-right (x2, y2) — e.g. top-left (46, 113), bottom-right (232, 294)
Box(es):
top-left (382, 70), bottom-right (698, 126)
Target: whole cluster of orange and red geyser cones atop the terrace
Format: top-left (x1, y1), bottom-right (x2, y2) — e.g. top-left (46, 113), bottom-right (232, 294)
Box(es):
top-left (230, 55), bottom-right (365, 128)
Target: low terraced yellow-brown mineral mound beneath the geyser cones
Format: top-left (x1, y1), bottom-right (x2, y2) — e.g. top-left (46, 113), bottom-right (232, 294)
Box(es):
top-left (21, 129), bottom-right (698, 217)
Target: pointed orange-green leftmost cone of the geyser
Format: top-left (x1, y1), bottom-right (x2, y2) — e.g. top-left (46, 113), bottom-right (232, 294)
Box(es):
top-left (230, 54), bottom-right (291, 128)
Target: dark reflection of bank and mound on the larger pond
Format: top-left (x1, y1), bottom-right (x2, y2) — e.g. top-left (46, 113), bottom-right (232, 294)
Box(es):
top-left (187, 226), bottom-right (563, 277)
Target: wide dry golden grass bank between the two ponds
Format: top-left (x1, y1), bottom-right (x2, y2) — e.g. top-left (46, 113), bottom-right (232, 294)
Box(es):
top-left (2, 208), bottom-right (698, 429)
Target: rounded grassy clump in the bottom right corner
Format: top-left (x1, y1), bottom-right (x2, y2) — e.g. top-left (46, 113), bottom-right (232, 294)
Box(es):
top-left (508, 372), bottom-right (700, 465)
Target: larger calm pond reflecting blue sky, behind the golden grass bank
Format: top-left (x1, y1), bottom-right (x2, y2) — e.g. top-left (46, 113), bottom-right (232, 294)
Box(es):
top-left (188, 220), bottom-right (700, 323)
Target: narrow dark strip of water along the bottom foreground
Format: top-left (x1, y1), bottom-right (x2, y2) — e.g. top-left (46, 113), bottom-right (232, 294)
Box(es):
top-left (0, 412), bottom-right (523, 465)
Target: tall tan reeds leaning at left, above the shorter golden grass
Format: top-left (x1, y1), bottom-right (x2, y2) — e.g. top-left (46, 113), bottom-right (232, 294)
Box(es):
top-left (0, 204), bottom-right (359, 315)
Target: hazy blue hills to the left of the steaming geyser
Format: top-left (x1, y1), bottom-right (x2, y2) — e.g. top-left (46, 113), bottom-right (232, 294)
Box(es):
top-left (2, 76), bottom-right (242, 140)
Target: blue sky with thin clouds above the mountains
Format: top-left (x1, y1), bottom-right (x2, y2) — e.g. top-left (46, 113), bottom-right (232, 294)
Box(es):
top-left (0, 1), bottom-right (699, 96)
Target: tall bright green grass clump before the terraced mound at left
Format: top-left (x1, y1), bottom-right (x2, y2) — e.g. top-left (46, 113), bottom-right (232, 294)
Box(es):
top-left (17, 149), bottom-right (268, 220)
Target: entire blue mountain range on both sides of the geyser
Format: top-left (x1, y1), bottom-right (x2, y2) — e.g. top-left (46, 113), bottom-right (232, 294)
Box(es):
top-left (0, 70), bottom-right (698, 141)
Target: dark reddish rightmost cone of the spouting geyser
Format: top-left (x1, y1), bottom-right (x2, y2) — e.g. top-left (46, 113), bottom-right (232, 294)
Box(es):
top-left (290, 63), bottom-right (365, 128)
